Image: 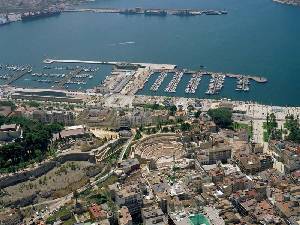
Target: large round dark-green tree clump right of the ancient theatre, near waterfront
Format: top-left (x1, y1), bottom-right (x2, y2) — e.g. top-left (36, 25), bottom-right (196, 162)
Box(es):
top-left (207, 107), bottom-right (233, 128)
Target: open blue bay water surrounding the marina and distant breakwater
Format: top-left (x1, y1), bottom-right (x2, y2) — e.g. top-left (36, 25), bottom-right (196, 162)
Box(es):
top-left (0, 0), bottom-right (300, 105)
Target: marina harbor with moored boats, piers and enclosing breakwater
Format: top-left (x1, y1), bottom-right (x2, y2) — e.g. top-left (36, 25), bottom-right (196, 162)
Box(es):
top-left (0, 59), bottom-right (268, 102)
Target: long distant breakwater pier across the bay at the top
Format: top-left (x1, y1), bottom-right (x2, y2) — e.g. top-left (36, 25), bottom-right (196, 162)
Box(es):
top-left (64, 7), bottom-right (228, 16)
